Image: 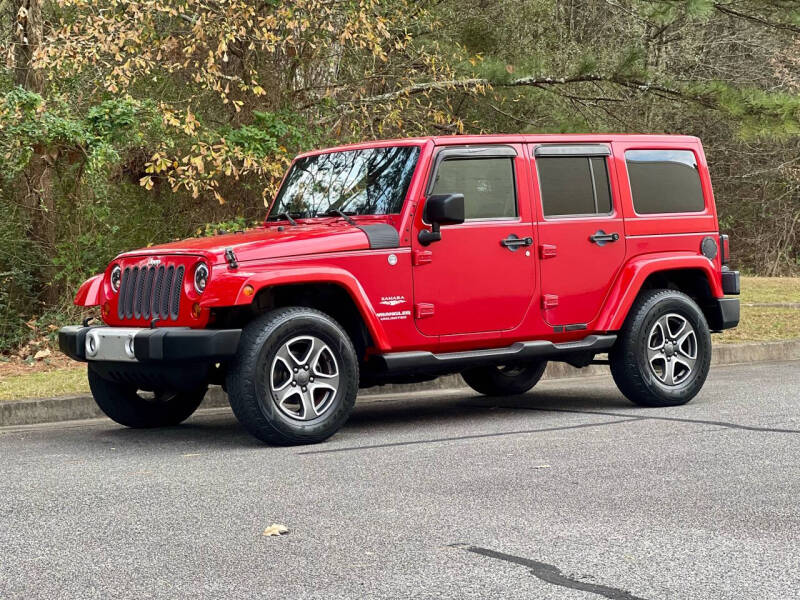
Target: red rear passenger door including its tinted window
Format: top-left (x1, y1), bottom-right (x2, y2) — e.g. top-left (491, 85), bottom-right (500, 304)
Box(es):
top-left (531, 144), bottom-right (625, 330)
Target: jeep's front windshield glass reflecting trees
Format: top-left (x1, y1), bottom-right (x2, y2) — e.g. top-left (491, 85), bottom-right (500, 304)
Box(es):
top-left (270, 146), bottom-right (419, 218)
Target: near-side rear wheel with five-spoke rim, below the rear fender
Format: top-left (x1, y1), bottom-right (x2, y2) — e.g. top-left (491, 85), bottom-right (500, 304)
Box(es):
top-left (609, 290), bottom-right (711, 406)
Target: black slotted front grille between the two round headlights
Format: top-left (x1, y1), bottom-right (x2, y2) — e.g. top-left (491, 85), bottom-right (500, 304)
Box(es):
top-left (117, 265), bottom-right (186, 321)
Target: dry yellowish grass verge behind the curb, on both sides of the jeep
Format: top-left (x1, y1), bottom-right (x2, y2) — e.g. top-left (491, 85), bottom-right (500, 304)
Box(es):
top-left (0, 277), bottom-right (800, 401)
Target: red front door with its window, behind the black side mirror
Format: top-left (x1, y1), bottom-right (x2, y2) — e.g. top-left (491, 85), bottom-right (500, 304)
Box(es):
top-left (413, 145), bottom-right (535, 336)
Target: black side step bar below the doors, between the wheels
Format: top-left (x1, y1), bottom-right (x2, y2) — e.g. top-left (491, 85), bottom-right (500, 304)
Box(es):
top-left (376, 335), bottom-right (617, 375)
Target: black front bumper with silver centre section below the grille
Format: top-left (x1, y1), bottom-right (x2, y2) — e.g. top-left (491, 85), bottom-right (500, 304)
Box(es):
top-left (58, 326), bottom-right (242, 363)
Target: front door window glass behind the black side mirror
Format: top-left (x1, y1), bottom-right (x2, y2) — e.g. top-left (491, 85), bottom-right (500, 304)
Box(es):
top-left (431, 158), bottom-right (517, 219)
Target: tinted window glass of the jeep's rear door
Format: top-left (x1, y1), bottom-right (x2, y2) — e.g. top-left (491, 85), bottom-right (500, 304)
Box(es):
top-left (536, 156), bottom-right (611, 217)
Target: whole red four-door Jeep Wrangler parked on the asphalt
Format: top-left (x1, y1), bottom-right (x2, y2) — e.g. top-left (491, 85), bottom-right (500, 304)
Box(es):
top-left (59, 135), bottom-right (739, 444)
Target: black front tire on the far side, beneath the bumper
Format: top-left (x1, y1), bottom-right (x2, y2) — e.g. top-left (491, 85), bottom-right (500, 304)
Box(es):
top-left (89, 365), bottom-right (208, 429)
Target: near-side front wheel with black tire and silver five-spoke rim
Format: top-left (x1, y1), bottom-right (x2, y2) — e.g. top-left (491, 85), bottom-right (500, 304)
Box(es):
top-left (227, 307), bottom-right (358, 445)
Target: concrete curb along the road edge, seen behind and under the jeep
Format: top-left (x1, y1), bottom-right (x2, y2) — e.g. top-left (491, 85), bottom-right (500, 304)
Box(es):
top-left (0, 339), bottom-right (800, 427)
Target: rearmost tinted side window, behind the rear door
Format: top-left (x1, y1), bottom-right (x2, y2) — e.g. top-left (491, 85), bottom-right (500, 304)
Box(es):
top-left (625, 150), bottom-right (705, 215)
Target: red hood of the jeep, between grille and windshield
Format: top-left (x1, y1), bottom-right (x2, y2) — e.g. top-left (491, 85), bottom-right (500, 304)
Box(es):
top-left (119, 220), bottom-right (370, 264)
